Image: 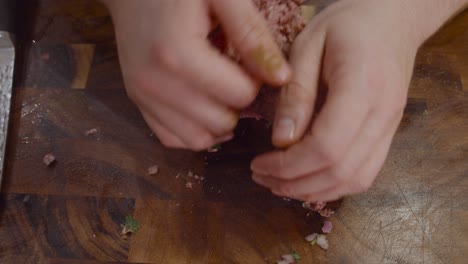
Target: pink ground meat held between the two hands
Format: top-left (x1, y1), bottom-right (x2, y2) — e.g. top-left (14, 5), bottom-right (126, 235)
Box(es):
top-left (210, 0), bottom-right (305, 121)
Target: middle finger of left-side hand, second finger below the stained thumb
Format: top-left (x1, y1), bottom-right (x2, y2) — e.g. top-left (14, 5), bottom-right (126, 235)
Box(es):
top-left (135, 70), bottom-right (238, 137)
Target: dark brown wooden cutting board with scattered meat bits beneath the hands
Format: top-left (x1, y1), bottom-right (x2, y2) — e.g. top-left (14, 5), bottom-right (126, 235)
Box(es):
top-left (0, 0), bottom-right (468, 264)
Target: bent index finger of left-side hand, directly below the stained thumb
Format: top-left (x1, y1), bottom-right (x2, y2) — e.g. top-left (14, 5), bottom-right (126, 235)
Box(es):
top-left (181, 41), bottom-right (260, 110)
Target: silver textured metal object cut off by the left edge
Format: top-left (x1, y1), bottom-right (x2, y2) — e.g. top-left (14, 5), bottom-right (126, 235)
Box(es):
top-left (0, 31), bottom-right (15, 188)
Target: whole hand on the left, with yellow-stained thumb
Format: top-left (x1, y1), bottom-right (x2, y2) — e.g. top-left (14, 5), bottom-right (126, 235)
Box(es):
top-left (103, 0), bottom-right (291, 150)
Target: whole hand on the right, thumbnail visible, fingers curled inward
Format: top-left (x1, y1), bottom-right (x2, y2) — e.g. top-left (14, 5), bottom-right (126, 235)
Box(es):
top-left (251, 0), bottom-right (461, 201)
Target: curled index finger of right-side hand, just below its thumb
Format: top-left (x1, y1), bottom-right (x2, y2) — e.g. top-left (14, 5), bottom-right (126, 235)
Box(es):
top-left (251, 68), bottom-right (375, 179)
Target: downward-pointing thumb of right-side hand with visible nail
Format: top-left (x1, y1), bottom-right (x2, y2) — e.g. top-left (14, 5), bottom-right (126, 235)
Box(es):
top-left (273, 32), bottom-right (325, 148)
